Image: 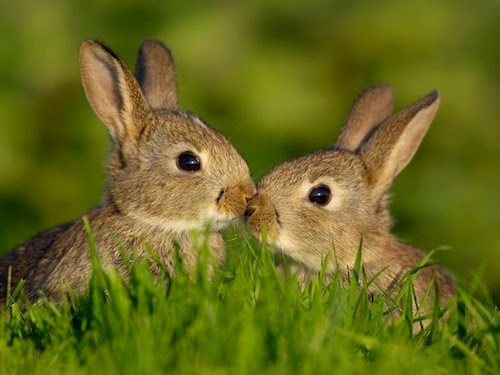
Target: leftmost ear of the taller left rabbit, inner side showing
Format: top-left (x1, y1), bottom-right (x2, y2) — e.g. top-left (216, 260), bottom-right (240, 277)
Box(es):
top-left (80, 40), bottom-right (151, 145)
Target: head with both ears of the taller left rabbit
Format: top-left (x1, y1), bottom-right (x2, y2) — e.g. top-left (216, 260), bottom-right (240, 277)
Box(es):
top-left (80, 40), bottom-right (255, 232)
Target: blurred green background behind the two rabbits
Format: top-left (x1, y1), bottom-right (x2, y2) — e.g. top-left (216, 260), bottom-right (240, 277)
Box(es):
top-left (0, 0), bottom-right (500, 301)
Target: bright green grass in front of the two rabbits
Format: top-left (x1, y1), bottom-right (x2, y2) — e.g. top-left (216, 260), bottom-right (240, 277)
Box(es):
top-left (0, 228), bottom-right (500, 374)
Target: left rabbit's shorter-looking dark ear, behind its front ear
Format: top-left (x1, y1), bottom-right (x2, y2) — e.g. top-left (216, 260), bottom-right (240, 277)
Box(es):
top-left (135, 39), bottom-right (177, 109)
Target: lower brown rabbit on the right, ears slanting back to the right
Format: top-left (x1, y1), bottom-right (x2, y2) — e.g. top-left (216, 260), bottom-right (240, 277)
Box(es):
top-left (245, 84), bottom-right (456, 320)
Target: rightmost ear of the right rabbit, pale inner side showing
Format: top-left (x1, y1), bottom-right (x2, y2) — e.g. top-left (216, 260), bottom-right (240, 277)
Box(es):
top-left (360, 91), bottom-right (439, 191)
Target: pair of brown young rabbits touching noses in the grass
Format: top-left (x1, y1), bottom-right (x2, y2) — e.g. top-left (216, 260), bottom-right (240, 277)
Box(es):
top-left (0, 40), bottom-right (454, 318)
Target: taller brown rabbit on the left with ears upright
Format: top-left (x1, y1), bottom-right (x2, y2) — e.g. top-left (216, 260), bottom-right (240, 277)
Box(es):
top-left (0, 40), bottom-right (255, 302)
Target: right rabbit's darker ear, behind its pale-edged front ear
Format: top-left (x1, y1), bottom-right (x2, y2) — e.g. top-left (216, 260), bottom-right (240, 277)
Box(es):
top-left (335, 85), bottom-right (394, 151)
